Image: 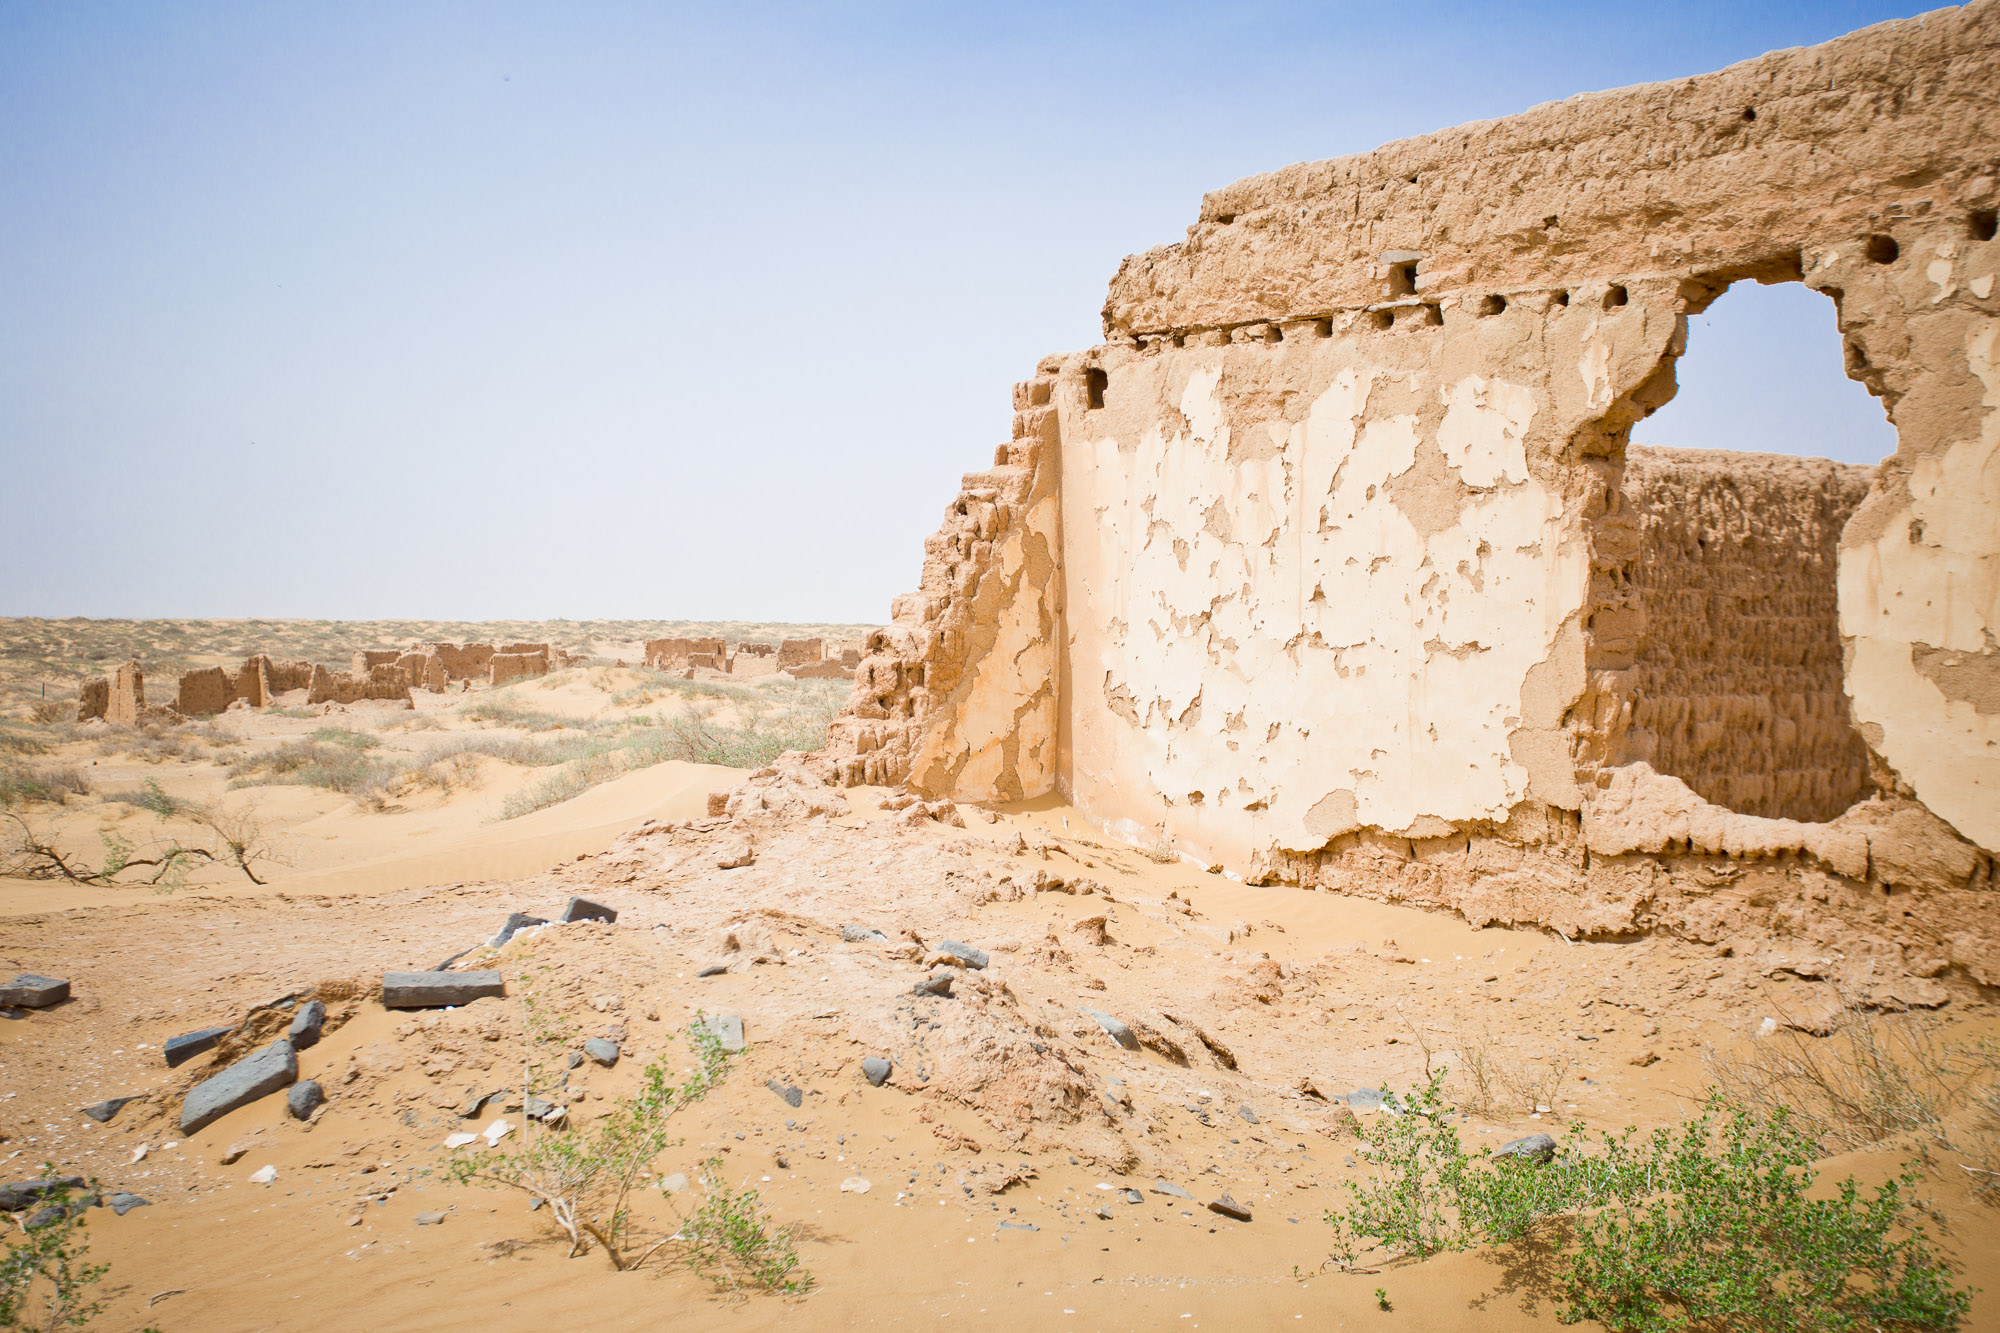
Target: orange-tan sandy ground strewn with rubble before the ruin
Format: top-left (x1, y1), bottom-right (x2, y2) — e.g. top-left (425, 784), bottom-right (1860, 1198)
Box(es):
top-left (0, 652), bottom-right (2000, 1331)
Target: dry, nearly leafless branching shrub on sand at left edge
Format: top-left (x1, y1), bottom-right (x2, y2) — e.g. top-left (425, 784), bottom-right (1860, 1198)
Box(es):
top-left (0, 781), bottom-right (278, 893)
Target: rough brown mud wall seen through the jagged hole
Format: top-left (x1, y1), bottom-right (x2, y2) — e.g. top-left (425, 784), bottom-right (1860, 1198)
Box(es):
top-left (1598, 446), bottom-right (1874, 823)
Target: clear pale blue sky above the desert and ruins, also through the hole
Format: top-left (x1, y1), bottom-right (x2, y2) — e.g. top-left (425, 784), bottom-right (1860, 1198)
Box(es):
top-left (0, 0), bottom-right (1924, 620)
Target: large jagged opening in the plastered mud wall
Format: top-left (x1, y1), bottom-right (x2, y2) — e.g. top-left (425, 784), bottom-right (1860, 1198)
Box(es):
top-left (1606, 282), bottom-right (1896, 823)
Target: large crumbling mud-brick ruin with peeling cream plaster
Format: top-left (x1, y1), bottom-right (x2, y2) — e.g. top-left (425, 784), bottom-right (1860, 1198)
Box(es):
top-left (822, 0), bottom-right (2000, 1003)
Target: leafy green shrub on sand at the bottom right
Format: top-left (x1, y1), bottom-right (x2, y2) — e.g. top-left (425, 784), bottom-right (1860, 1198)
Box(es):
top-left (1326, 1071), bottom-right (1972, 1333)
